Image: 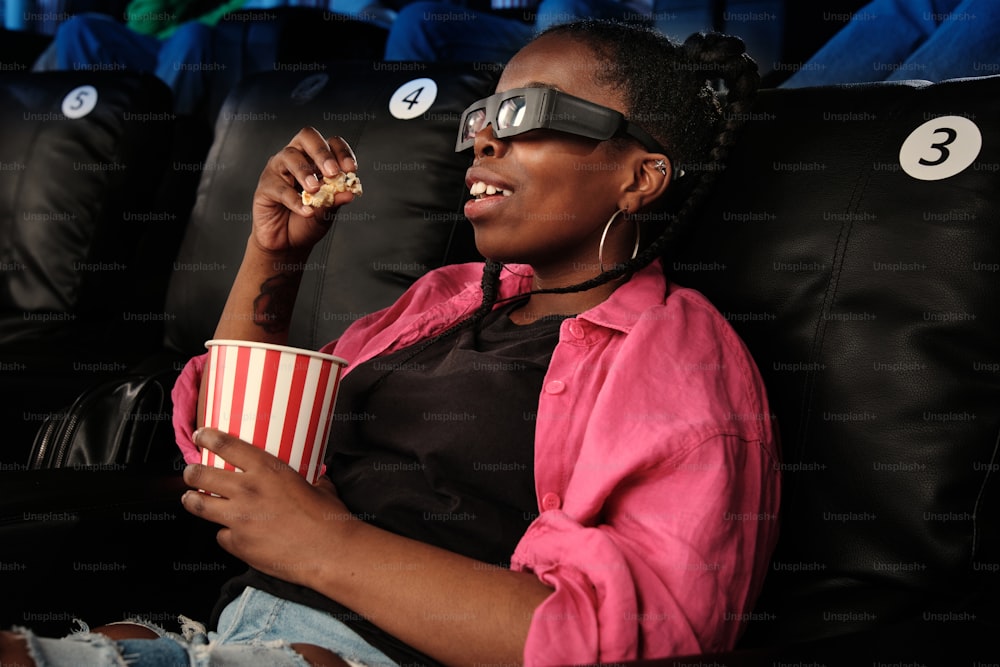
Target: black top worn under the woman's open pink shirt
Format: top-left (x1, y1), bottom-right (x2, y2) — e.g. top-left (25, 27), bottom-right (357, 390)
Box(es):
top-left (213, 303), bottom-right (564, 664)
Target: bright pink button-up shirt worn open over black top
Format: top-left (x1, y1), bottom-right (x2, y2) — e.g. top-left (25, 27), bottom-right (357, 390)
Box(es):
top-left (173, 263), bottom-right (780, 665)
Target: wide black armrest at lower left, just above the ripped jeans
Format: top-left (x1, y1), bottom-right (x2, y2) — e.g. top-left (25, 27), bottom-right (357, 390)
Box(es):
top-left (0, 467), bottom-right (246, 636)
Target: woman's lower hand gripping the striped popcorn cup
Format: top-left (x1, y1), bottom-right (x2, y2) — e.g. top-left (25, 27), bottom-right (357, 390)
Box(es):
top-left (181, 428), bottom-right (354, 586)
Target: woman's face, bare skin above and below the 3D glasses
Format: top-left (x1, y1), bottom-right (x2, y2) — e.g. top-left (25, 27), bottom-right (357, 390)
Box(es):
top-left (465, 35), bottom-right (642, 280)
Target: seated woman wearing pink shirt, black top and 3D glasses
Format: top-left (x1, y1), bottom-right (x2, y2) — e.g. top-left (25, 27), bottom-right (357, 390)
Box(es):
top-left (0, 22), bottom-right (778, 665)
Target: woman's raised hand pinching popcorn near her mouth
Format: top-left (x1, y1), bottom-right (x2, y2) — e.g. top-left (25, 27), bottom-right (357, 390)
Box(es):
top-left (251, 127), bottom-right (358, 254)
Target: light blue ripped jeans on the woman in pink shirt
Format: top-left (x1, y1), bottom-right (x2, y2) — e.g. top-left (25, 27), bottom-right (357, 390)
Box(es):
top-left (14, 588), bottom-right (396, 667)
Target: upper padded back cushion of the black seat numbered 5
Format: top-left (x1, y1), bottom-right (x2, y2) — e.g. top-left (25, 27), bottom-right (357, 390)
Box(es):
top-left (0, 71), bottom-right (173, 343)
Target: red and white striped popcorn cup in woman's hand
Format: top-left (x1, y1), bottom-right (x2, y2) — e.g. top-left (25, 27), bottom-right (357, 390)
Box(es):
top-left (198, 340), bottom-right (347, 483)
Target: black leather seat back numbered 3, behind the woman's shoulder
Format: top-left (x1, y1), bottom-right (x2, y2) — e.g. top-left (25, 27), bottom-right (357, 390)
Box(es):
top-left (670, 77), bottom-right (1000, 642)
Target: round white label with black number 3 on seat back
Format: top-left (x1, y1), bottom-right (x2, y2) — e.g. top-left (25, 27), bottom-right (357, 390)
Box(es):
top-left (899, 116), bottom-right (983, 181)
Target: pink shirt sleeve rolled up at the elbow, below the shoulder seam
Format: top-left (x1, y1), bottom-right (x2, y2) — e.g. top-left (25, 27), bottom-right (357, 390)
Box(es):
top-left (512, 435), bottom-right (778, 665)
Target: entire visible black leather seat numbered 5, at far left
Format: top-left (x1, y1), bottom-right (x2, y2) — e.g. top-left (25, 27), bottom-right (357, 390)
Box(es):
top-left (0, 71), bottom-right (176, 463)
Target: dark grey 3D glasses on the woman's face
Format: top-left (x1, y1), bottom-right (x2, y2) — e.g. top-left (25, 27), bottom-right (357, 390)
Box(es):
top-left (455, 88), bottom-right (666, 153)
